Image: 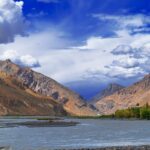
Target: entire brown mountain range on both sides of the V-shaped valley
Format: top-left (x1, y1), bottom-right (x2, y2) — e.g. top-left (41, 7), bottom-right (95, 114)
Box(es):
top-left (0, 59), bottom-right (150, 116)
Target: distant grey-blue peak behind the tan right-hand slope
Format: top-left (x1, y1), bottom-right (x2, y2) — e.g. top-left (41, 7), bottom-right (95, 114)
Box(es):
top-left (90, 83), bottom-right (124, 103)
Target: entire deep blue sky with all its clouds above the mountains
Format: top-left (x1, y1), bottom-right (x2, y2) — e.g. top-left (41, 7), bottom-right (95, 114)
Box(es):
top-left (0, 0), bottom-right (150, 99)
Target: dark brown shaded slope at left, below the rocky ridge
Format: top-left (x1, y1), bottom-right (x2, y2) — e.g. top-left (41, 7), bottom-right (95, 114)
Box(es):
top-left (0, 72), bottom-right (66, 116)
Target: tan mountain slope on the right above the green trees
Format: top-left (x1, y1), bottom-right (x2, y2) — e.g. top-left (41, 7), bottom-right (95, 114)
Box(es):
top-left (95, 74), bottom-right (150, 114)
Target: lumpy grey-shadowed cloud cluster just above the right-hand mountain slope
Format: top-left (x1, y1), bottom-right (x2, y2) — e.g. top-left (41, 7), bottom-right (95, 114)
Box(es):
top-left (106, 43), bottom-right (150, 77)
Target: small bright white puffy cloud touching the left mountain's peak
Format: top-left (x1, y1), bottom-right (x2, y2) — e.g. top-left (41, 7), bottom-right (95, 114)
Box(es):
top-left (0, 50), bottom-right (40, 68)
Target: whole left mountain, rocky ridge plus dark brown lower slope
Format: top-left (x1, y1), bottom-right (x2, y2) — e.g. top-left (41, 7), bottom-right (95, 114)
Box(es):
top-left (0, 60), bottom-right (96, 115)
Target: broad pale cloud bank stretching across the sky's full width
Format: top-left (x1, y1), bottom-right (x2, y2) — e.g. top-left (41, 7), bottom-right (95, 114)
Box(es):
top-left (0, 9), bottom-right (150, 83)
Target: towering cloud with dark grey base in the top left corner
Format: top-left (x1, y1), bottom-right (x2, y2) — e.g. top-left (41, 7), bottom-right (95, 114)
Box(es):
top-left (0, 0), bottom-right (25, 43)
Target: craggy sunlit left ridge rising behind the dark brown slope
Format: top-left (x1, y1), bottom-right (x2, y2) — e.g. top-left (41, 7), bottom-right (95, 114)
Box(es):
top-left (0, 60), bottom-right (96, 115)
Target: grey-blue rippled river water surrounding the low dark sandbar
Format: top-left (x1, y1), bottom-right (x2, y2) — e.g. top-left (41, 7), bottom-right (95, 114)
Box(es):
top-left (0, 119), bottom-right (150, 150)
